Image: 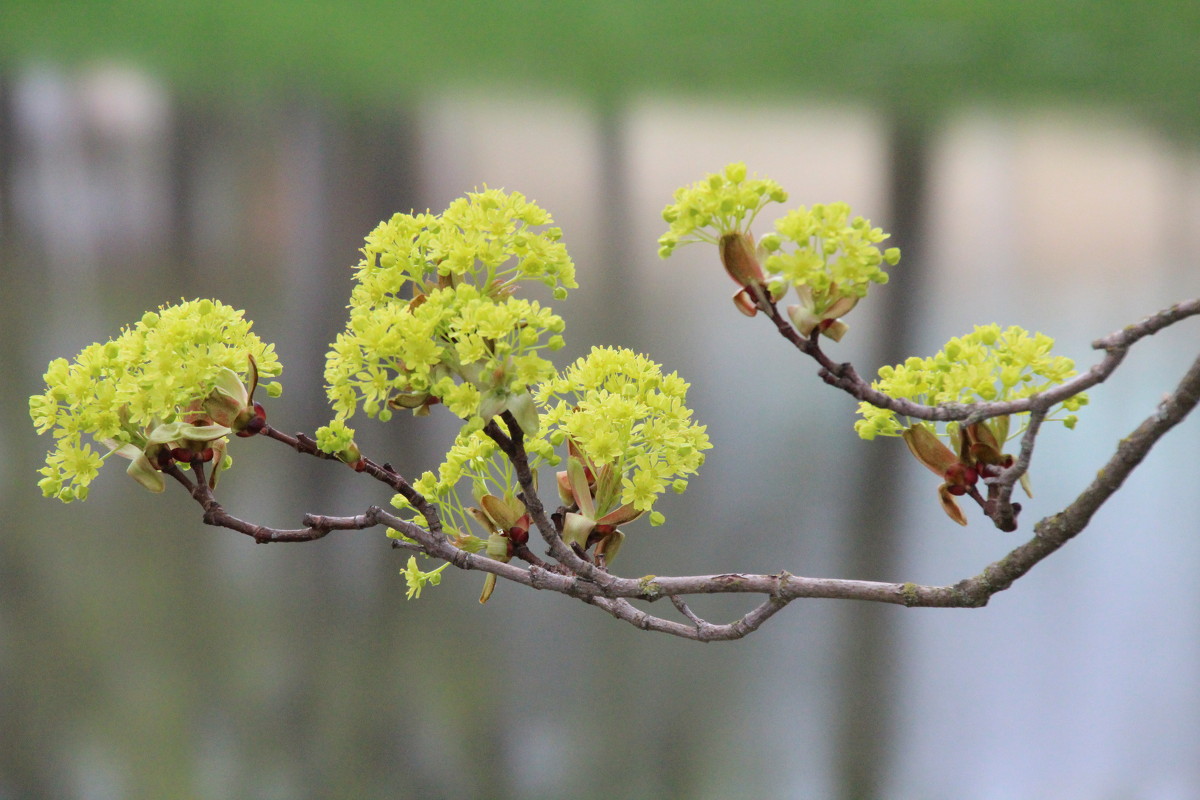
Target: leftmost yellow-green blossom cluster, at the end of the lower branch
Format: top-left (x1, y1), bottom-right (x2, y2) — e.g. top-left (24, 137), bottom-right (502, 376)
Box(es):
top-left (29, 300), bottom-right (282, 501)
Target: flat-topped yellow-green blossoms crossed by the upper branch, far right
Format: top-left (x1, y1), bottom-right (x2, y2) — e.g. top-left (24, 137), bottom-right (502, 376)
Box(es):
top-left (854, 325), bottom-right (1087, 446)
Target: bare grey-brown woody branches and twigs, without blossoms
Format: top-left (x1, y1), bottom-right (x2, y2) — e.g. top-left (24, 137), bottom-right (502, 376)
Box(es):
top-left (152, 300), bottom-right (1200, 642)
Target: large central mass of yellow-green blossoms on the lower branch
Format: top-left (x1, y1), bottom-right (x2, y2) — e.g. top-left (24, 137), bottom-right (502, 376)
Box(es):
top-left (317, 190), bottom-right (709, 587)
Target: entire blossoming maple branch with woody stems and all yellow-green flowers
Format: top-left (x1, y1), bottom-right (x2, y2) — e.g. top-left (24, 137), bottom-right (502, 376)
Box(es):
top-left (30, 164), bottom-right (1200, 640)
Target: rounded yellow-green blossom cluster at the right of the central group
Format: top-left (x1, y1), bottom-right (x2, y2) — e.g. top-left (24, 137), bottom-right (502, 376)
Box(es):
top-left (536, 348), bottom-right (712, 558)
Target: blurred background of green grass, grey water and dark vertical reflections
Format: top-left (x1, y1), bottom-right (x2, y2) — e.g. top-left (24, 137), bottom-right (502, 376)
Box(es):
top-left (0, 0), bottom-right (1200, 799)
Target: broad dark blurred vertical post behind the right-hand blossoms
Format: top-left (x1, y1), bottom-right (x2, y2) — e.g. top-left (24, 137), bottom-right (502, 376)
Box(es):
top-left (834, 112), bottom-right (930, 800)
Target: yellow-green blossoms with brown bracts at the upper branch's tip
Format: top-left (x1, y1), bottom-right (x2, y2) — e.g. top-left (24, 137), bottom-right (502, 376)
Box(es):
top-left (659, 163), bottom-right (900, 341)
